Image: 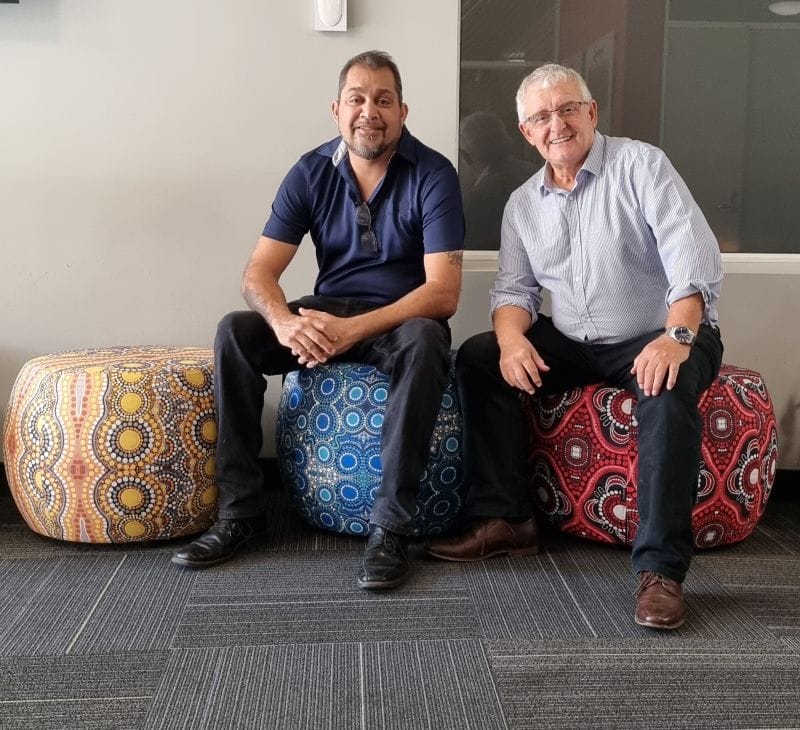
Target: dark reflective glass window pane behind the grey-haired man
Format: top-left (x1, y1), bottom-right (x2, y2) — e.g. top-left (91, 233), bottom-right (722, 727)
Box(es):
top-left (459, 0), bottom-right (800, 253)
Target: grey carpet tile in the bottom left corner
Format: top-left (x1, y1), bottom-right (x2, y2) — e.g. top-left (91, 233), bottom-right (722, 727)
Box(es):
top-left (0, 652), bottom-right (168, 730)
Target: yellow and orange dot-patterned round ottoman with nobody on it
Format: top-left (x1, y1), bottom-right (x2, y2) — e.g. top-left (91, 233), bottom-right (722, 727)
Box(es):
top-left (4, 347), bottom-right (217, 543)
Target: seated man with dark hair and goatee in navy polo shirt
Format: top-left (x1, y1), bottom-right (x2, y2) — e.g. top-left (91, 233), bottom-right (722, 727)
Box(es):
top-left (173, 51), bottom-right (464, 589)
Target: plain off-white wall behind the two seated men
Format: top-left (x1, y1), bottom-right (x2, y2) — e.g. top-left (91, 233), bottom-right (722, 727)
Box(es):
top-left (0, 0), bottom-right (800, 468)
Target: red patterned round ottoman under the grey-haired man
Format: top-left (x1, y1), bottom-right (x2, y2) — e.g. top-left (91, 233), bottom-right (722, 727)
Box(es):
top-left (526, 365), bottom-right (778, 548)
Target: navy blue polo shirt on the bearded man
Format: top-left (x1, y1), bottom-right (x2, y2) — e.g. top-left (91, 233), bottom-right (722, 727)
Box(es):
top-left (264, 128), bottom-right (464, 305)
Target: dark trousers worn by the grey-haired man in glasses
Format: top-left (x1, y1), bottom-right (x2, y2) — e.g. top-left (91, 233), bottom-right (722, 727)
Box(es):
top-left (456, 316), bottom-right (723, 581)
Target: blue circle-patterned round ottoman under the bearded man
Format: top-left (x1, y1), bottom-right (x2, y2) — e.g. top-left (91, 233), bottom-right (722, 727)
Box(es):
top-left (276, 356), bottom-right (463, 535)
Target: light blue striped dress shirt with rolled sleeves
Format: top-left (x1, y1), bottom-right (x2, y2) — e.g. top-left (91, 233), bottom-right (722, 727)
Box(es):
top-left (491, 132), bottom-right (722, 343)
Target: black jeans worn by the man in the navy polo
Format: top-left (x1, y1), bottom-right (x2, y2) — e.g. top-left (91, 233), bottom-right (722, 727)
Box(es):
top-left (214, 296), bottom-right (450, 534)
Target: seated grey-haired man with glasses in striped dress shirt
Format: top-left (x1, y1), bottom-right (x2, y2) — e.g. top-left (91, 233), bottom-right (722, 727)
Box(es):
top-left (429, 64), bottom-right (722, 629)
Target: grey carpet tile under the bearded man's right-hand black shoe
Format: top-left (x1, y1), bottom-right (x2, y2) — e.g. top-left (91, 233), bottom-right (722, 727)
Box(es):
top-left (173, 552), bottom-right (480, 648)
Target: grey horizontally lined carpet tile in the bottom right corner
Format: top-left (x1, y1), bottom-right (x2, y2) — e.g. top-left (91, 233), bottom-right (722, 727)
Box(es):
top-left (487, 633), bottom-right (800, 730)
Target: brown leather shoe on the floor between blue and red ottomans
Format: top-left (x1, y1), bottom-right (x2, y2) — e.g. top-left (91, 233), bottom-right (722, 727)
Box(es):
top-left (425, 517), bottom-right (539, 561)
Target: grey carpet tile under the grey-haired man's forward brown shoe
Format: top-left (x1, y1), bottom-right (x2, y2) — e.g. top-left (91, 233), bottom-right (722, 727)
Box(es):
top-left (463, 539), bottom-right (772, 640)
